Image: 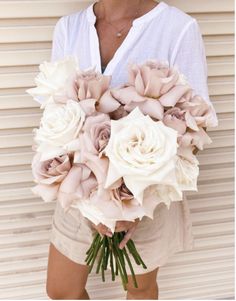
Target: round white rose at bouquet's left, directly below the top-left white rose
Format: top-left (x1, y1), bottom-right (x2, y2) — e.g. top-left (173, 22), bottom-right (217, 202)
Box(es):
top-left (33, 100), bottom-right (85, 161)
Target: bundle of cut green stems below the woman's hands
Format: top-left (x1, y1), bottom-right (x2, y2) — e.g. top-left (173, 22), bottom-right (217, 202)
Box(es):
top-left (85, 232), bottom-right (147, 290)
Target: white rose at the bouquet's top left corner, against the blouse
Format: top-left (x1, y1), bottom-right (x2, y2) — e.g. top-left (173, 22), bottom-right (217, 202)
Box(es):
top-left (26, 57), bottom-right (78, 109)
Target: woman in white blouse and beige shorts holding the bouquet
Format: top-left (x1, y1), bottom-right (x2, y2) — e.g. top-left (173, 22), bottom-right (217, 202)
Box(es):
top-left (47, 0), bottom-right (217, 299)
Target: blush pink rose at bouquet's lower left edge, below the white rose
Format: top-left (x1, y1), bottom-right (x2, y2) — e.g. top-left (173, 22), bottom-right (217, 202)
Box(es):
top-left (31, 153), bottom-right (72, 202)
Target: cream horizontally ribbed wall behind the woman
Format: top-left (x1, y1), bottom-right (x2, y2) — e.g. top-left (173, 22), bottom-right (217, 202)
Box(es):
top-left (0, 0), bottom-right (234, 300)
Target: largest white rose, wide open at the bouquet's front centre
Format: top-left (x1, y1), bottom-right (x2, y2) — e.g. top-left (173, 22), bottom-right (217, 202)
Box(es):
top-left (104, 108), bottom-right (178, 203)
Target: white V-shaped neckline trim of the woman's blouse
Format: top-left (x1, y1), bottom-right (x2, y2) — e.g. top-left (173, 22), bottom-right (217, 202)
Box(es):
top-left (87, 1), bottom-right (168, 75)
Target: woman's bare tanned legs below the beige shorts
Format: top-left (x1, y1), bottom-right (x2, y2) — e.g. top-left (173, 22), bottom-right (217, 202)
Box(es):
top-left (46, 243), bottom-right (158, 300)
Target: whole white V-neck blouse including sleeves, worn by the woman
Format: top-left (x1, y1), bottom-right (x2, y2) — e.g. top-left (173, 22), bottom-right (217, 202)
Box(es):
top-left (51, 1), bottom-right (218, 126)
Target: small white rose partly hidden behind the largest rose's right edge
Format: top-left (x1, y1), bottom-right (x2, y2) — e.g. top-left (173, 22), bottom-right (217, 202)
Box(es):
top-left (176, 156), bottom-right (199, 191)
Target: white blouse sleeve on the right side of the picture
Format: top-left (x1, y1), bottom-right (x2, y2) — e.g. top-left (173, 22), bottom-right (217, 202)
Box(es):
top-left (170, 18), bottom-right (218, 126)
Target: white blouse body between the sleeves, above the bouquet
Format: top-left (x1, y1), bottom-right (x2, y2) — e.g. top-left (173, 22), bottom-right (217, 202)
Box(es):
top-left (58, 1), bottom-right (194, 86)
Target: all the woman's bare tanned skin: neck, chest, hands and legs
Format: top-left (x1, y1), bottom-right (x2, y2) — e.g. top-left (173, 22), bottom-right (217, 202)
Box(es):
top-left (46, 0), bottom-right (159, 300)
